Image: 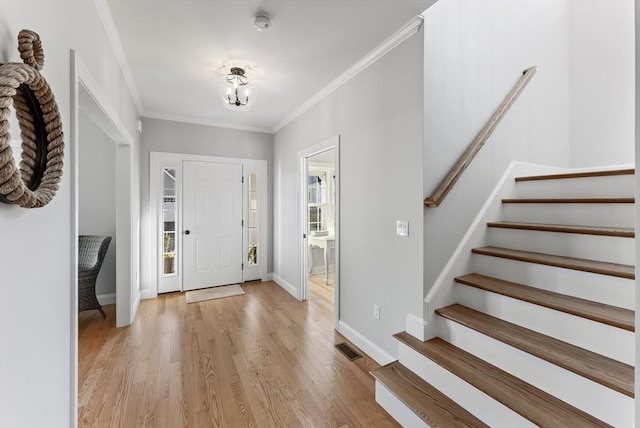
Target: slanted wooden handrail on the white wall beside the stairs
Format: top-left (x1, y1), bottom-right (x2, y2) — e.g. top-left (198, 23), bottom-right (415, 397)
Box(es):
top-left (424, 66), bottom-right (536, 207)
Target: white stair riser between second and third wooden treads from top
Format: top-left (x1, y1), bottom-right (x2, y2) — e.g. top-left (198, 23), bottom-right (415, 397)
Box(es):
top-left (502, 204), bottom-right (635, 228)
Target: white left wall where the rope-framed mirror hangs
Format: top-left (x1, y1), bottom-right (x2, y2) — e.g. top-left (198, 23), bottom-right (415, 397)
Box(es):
top-left (0, 0), bottom-right (137, 428)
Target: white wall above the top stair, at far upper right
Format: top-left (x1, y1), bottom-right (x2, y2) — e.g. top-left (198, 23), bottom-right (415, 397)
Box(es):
top-left (569, 0), bottom-right (635, 167)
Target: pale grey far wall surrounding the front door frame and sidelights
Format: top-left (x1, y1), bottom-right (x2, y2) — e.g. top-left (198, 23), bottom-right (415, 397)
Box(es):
top-left (140, 118), bottom-right (273, 290)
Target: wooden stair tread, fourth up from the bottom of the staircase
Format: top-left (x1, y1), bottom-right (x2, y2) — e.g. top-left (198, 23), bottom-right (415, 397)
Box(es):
top-left (455, 273), bottom-right (635, 331)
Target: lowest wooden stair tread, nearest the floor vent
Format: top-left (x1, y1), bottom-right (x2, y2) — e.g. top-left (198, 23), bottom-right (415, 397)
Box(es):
top-left (371, 361), bottom-right (488, 427)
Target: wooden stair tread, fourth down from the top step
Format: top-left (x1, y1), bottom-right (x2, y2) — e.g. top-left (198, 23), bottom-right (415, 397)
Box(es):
top-left (471, 247), bottom-right (635, 279)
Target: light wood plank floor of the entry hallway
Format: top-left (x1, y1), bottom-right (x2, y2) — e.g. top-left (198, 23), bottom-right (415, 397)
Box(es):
top-left (78, 281), bottom-right (398, 428)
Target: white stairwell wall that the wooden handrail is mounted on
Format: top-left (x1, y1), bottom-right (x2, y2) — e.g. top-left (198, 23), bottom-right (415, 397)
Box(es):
top-left (424, 0), bottom-right (570, 295)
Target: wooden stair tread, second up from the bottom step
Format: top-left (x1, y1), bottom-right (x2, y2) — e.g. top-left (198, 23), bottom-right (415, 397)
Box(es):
top-left (394, 333), bottom-right (609, 427)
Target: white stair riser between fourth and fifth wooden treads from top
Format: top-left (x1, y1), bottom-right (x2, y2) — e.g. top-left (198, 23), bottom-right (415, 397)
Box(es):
top-left (471, 254), bottom-right (635, 309)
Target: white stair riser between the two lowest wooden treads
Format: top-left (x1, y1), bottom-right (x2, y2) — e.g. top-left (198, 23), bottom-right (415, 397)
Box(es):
top-left (399, 343), bottom-right (535, 427)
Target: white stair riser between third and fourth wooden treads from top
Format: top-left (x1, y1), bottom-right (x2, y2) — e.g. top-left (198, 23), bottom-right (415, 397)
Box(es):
top-left (487, 227), bottom-right (636, 265)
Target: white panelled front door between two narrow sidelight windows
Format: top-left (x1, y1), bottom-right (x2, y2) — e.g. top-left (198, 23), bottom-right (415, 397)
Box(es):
top-left (182, 161), bottom-right (243, 291)
